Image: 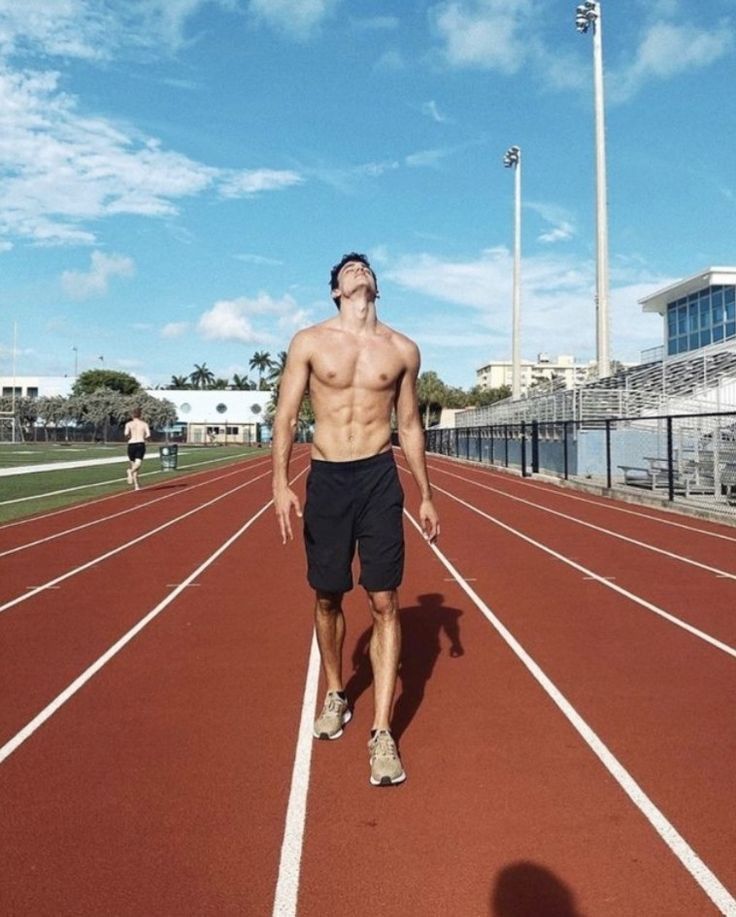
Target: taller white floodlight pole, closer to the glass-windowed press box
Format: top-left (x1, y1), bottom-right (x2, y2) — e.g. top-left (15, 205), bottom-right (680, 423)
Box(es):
top-left (575, 0), bottom-right (611, 379)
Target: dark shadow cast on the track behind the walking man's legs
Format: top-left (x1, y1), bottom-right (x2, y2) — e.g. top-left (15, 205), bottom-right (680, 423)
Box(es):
top-left (345, 592), bottom-right (465, 740)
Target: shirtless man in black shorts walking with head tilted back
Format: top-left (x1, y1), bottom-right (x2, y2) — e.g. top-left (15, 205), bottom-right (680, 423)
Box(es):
top-left (272, 252), bottom-right (440, 786)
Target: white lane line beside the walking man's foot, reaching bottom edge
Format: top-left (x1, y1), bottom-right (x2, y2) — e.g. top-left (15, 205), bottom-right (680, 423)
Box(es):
top-left (273, 633), bottom-right (319, 917)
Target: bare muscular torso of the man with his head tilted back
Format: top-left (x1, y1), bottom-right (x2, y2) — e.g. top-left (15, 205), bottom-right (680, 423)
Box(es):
top-left (307, 319), bottom-right (412, 462)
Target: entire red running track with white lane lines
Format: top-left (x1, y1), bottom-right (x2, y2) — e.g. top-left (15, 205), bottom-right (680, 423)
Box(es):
top-left (0, 451), bottom-right (736, 917)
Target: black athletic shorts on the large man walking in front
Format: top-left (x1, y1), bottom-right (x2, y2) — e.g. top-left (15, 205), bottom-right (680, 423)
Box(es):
top-left (304, 451), bottom-right (404, 592)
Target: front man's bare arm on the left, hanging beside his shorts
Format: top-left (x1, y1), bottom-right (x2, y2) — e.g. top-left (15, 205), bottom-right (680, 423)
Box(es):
top-left (271, 332), bottom-right (309, 544)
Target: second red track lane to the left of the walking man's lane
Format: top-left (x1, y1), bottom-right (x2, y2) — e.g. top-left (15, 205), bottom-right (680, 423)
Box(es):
top-left (0, 462), bottom-right (308, 743)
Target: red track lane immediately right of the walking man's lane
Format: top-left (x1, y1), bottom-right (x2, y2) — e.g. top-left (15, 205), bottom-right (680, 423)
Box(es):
top-left (408, 466), bottom-right (736, 900)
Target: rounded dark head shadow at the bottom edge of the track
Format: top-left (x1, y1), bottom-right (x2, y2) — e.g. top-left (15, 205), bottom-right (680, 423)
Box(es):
top-left (490, 860), bottom-right (585, 917)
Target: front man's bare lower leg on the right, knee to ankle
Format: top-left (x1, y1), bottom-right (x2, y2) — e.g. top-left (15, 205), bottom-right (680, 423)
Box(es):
top-left (368, 589), bottom-right (401, 729)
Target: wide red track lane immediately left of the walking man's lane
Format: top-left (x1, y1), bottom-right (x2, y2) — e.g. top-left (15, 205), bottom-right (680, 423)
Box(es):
top-left (0, 484), bottom-right (312, 915)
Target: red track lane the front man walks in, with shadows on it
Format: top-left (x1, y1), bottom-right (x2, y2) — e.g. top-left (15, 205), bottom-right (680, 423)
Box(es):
top-left (298, 494), bottom-right (717, 917)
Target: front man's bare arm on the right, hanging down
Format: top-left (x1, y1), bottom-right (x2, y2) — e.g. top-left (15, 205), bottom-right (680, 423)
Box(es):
top-left (396, 343), bottom-right (440, 542)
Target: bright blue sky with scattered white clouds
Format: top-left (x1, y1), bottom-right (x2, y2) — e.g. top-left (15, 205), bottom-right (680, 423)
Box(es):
top-left (0, 0), bottom-right (736, 388)
